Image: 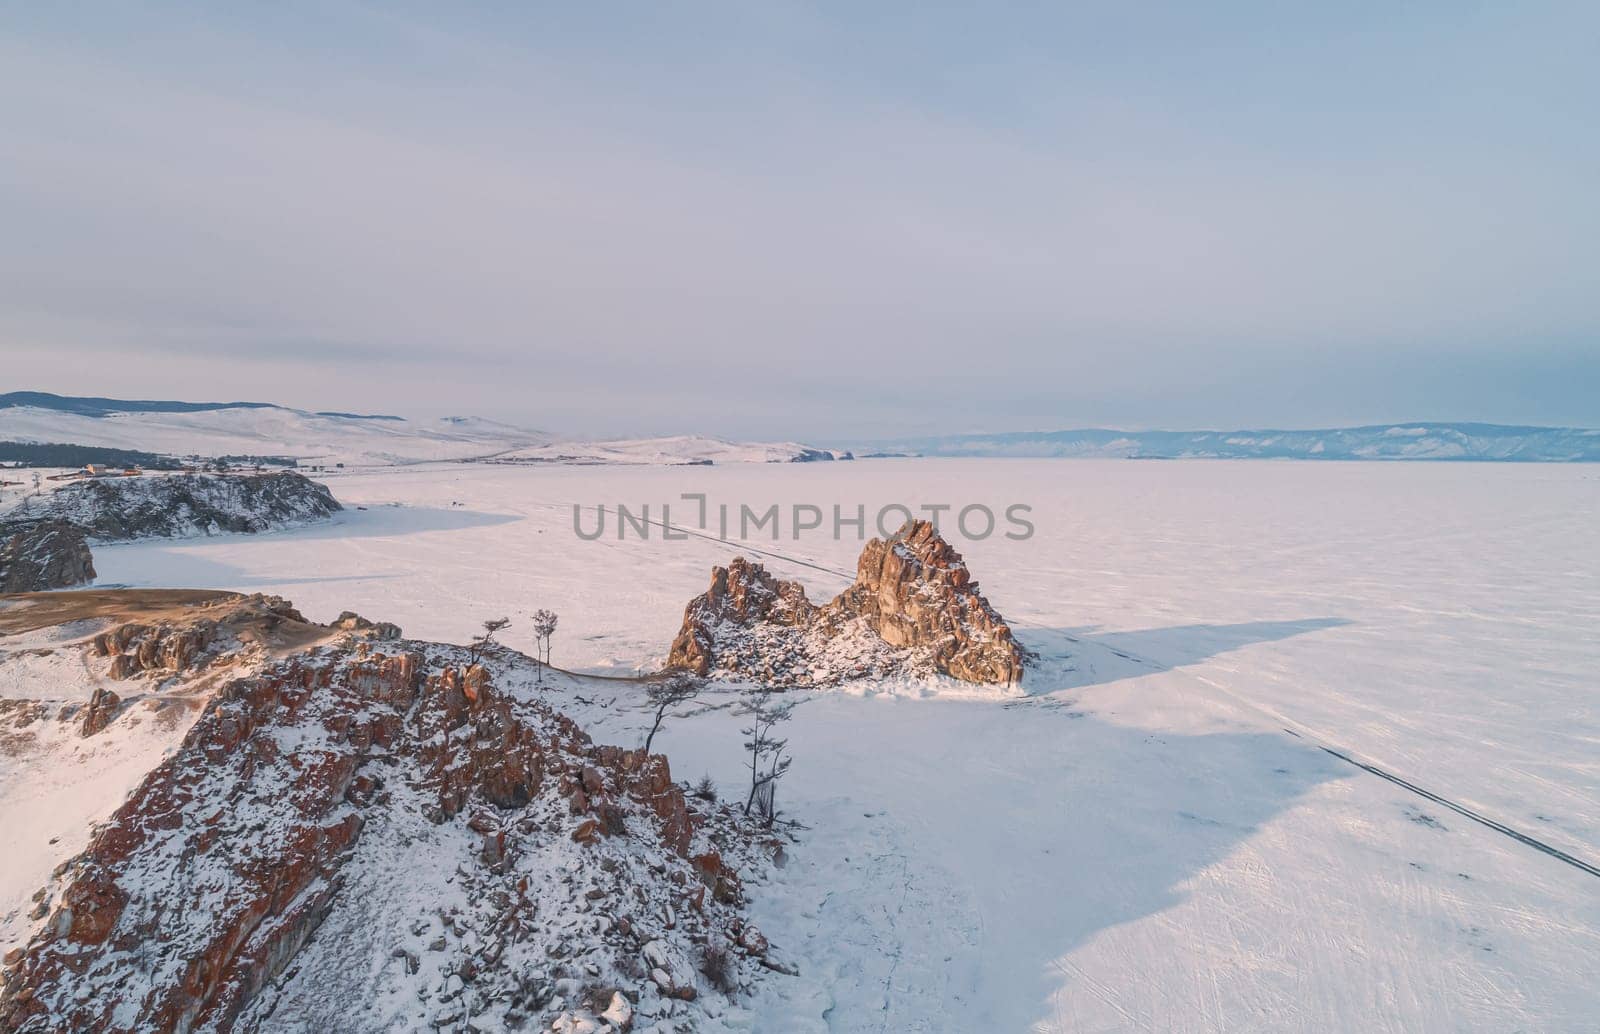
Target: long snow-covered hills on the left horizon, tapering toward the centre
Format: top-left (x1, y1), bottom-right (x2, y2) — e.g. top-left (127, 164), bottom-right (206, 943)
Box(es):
top-left (0, 392), bottom-right (835, 466)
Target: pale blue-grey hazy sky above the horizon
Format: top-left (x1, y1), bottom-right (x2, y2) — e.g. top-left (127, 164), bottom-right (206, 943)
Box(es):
top-left (0, 2), bottom-right (1600, 440)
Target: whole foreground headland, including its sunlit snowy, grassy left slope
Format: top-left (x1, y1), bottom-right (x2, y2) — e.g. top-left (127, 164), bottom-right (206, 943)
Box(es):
top-left (0, 591), bottom-right (792, 1034)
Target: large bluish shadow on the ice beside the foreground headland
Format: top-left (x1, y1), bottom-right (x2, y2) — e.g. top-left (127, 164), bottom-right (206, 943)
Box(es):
top-left (630, 681), bottom-right (1350, 1031)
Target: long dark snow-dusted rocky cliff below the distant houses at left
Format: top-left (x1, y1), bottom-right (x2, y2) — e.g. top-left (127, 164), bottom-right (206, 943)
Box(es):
top-left (13, 471), bottom-right (344, 541)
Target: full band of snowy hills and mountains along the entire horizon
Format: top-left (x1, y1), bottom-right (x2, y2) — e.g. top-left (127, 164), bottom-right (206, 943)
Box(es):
top-left (9, 391), bottom-right (1600, 464)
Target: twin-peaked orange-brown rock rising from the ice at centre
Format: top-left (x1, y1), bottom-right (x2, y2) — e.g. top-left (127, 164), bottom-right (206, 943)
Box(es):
top-left (667, 520), bottom-right (1026, 687)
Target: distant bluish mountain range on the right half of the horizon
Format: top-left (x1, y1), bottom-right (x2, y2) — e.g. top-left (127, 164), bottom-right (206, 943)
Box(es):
top-left (853, 423), bottom-right (1600, 463)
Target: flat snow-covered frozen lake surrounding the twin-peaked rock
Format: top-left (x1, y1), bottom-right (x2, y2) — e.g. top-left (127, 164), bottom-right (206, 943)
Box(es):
top-left (96, 459), bottom-right (1600, 1031)
